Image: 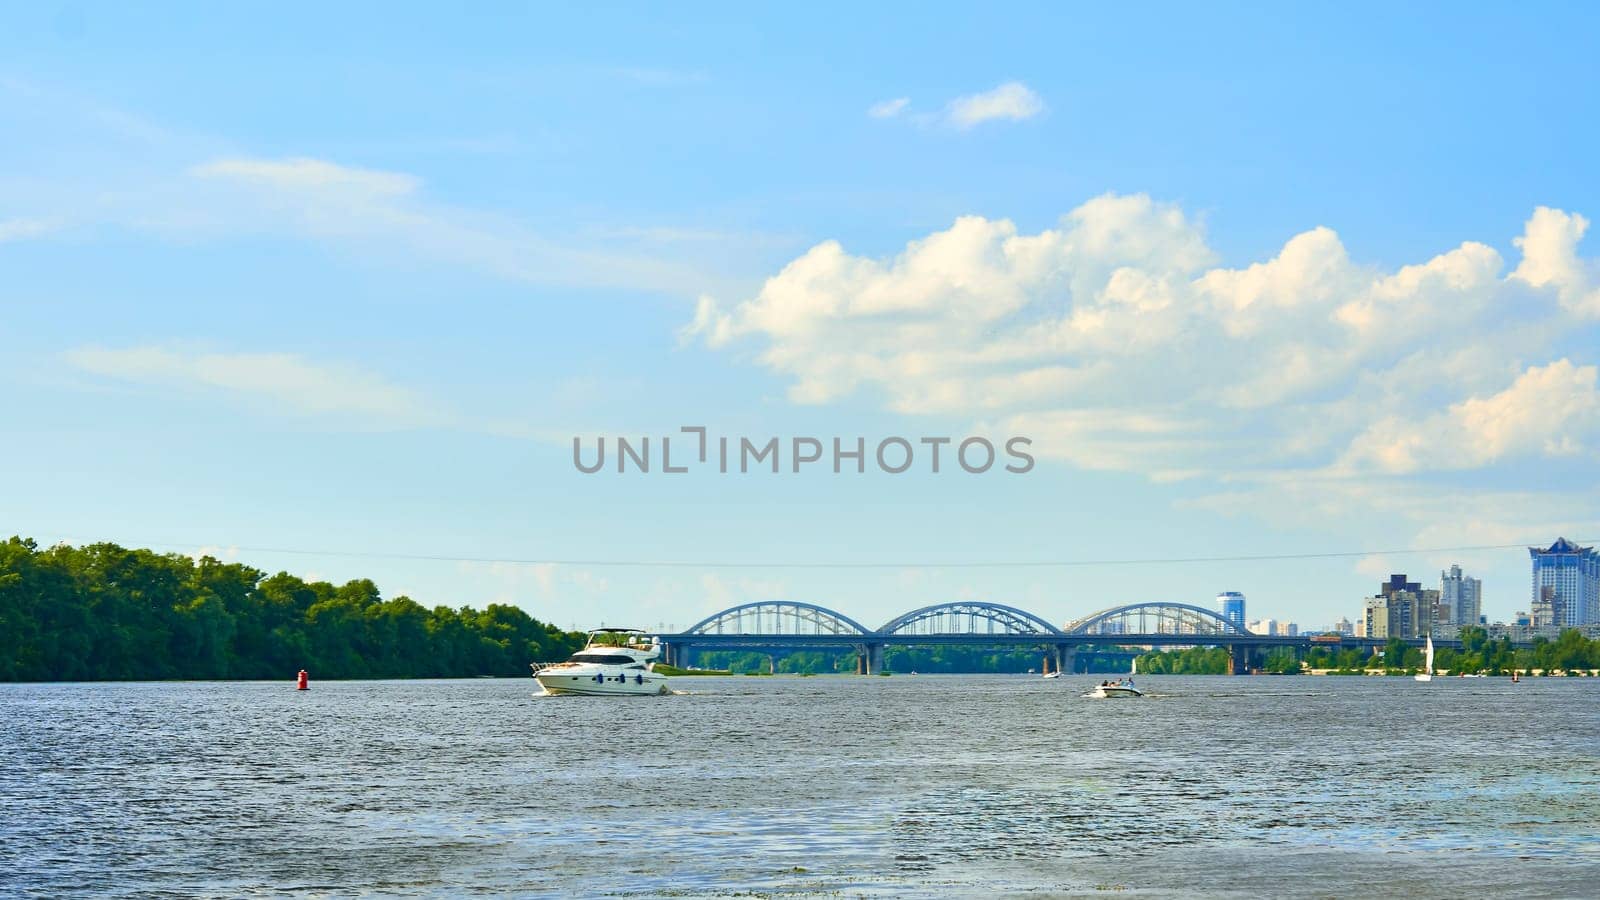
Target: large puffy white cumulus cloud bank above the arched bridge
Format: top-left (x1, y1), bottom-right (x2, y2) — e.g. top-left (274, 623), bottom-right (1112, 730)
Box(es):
top-left (680, 195), bottom-right (1595, 479)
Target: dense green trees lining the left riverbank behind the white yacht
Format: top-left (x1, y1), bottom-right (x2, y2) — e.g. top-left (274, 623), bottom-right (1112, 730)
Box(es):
top-left (0, 538), bottom-right (582, 681)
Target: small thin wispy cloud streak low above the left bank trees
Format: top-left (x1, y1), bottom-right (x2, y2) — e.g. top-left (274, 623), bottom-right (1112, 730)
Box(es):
top-left (66, 346), bottom-right (443, 426)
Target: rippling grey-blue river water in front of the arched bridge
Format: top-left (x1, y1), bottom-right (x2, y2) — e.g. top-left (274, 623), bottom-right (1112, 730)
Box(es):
top-left (0, 676), bottom-right (1600, 897)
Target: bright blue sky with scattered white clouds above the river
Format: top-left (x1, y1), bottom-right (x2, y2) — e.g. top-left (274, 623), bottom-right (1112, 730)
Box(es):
top-left (0, 3), bottom-right (1600, 626)
